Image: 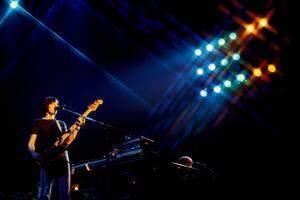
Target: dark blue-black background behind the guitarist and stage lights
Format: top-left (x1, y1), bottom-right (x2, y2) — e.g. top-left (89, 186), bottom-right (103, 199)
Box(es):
top-left (0, 0), bottom-right (298, 197)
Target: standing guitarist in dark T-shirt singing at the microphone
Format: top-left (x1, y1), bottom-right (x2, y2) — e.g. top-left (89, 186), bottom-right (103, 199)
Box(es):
top-left (28, 96), bottom-right (85, 200)
